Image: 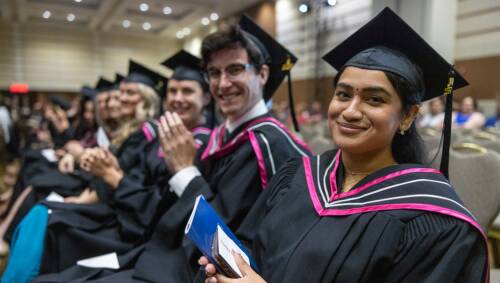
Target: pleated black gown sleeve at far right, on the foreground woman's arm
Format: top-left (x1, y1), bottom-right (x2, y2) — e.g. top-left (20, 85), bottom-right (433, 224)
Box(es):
top-left (386, 213), bottom-right (487, 282)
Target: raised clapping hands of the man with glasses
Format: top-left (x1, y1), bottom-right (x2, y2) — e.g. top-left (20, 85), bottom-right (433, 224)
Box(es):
top-left (158, 111), bottom-right (196, 174)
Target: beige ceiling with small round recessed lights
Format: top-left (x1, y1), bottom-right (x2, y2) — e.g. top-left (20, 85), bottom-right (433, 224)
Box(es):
top-left (0, 0), bottom-right (261, 38)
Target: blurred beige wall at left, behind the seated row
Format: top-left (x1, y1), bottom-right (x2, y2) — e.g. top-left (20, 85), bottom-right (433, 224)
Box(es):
top-left (0, 22), bottom-right (180, 91)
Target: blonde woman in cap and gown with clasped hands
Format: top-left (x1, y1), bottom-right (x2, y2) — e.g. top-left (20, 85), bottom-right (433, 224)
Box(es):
top-left (0, 61), bottom-right (164, 278)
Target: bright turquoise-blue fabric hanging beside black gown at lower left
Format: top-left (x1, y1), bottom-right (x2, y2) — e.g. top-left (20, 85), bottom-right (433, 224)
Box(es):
top-left (2, 204), bottom-right (49, 283)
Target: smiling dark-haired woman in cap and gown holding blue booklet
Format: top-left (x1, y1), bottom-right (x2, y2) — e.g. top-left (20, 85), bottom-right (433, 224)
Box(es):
top-left (199, 8), bottom-right (489, 283)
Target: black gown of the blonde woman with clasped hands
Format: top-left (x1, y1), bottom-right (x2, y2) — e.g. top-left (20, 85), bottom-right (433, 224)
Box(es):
top-left (34, 122), bottom-right (159, 274)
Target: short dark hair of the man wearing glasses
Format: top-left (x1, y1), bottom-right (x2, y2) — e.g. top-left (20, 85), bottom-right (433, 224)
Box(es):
top-left (201, 25), bottom-right (267, 71)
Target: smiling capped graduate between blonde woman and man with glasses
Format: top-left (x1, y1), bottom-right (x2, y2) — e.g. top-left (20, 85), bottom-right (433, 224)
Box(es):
top-left (29, 51), bottom-right (210, 282)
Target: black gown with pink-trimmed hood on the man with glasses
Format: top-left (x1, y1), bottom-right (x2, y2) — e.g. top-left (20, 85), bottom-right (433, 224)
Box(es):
top-left (39, 115), bottom-right (310, 282)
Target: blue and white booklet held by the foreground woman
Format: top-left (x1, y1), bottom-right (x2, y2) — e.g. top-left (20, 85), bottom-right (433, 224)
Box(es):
top-left (184, 195), bottom-right (257, 278)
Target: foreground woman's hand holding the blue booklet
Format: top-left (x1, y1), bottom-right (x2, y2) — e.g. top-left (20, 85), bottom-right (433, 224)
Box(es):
top-left (198, 252), bottom-right (266, 283)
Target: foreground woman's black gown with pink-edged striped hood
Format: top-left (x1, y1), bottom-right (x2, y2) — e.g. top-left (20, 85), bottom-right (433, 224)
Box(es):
top-left (237, 151), bottom-right (488, 283)
